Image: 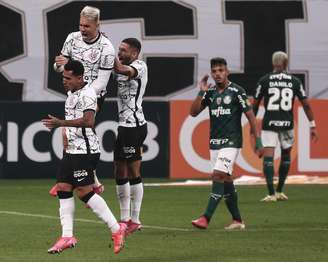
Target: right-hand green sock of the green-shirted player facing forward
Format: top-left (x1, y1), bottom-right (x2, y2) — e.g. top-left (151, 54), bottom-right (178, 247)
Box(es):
top-left (224, 182), bottom-right (242, 222)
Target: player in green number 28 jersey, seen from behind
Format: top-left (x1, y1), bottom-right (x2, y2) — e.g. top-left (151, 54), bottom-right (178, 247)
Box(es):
top-left (254, 51), bottom-right (318, 202)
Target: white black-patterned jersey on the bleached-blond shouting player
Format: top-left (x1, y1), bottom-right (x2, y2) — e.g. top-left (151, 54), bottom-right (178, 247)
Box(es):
top-left (61, 31), bottom-right (115, 97)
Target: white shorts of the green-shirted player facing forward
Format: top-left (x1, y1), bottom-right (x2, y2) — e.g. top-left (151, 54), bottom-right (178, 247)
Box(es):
top-left (210, 147), bottom-right (240, 176)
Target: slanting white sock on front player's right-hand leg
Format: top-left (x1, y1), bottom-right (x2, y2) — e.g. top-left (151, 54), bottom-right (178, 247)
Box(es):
top-left (87, 194), bottom-right (120, 233)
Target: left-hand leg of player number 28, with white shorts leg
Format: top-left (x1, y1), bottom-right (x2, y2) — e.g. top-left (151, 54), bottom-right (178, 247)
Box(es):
top-left (261, 130), bottom-right (278, 202)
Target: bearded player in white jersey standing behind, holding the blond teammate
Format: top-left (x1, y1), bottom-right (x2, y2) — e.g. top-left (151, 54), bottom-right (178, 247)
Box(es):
top-left (114, 38), bottom-right (148, 234)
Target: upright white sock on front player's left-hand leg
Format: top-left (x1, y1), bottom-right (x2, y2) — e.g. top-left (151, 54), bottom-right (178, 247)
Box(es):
top-left (59, 197), bottom-right (75, 237)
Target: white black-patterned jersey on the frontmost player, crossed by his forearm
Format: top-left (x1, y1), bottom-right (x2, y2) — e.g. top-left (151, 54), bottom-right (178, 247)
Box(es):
top-left (65, 84), bottom-right (100, 154)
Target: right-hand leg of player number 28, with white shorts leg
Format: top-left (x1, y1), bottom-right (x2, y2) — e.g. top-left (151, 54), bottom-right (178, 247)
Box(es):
top-left (276, 130), bottom-right (294, 200)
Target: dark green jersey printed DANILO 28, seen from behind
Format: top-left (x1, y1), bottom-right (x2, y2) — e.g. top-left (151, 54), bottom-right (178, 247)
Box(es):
top-left (255, 72), bottom-right (306, 131)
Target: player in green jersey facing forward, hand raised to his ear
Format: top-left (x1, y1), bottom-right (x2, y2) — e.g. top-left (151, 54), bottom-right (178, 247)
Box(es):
top-left (190, 57), bottom-right (262, 230)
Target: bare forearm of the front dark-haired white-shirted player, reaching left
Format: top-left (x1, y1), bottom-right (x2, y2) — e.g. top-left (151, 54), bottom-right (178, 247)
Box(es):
top-left (41, 110), bottom-right (95, 129)
